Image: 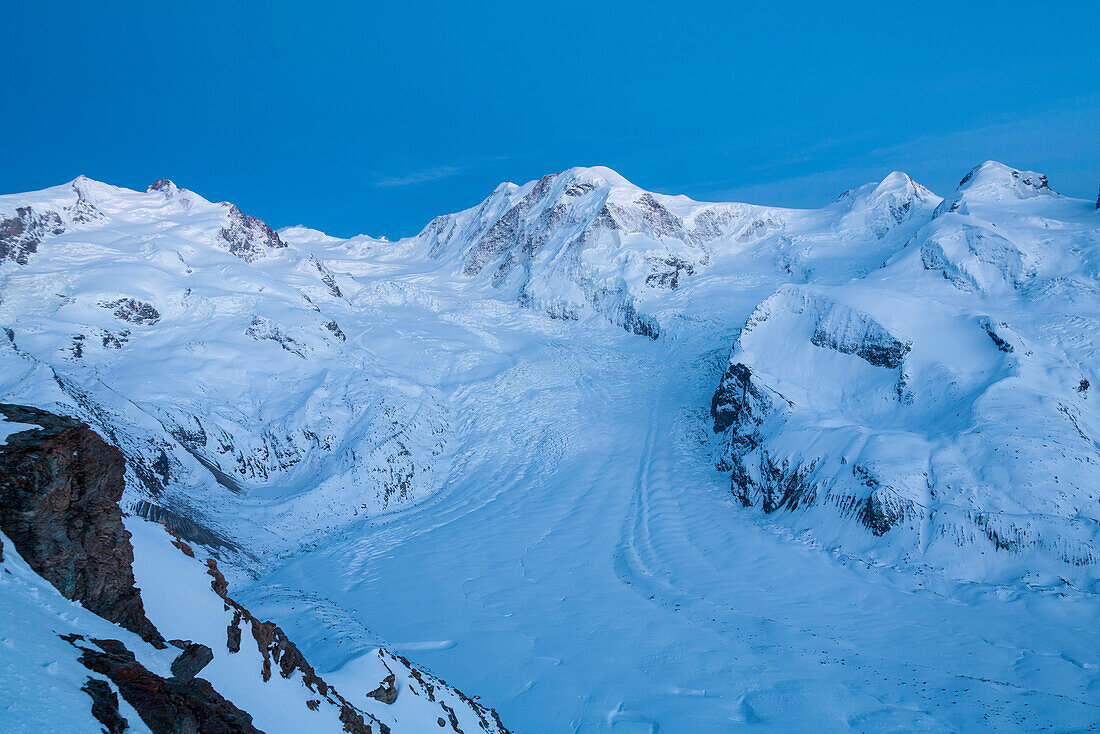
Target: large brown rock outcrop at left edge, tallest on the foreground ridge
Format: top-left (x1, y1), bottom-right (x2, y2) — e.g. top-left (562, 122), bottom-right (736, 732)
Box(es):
top-left (0, 404), bottom-right (164, 647)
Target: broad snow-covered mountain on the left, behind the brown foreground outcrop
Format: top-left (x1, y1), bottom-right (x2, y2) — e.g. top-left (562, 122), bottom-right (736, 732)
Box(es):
top-left (0, 177), bottom-right (447, 552)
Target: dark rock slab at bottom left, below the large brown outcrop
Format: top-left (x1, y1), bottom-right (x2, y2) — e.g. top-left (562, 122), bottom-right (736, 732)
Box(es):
top-left (70, 638), bottom-right (263, 734)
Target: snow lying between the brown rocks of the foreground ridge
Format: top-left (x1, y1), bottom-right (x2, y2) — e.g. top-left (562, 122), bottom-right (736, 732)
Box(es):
top-left (0, 518), bottom-right (502, 734)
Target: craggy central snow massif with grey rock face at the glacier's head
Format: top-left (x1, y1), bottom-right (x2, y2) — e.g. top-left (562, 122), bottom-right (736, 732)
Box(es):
top-left (416, 167), bottom-right (939, 338)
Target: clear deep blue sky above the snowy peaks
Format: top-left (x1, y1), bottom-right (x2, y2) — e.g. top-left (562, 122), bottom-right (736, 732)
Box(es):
top-left (0, 0), bottom-right (1100, 237)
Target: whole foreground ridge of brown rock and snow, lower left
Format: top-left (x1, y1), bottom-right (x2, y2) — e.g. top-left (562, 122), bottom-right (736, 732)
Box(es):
top-left (0, 404), bottom-right (507, 734)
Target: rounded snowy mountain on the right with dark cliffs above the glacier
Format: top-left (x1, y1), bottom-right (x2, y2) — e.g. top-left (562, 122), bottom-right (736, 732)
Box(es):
top-left (713, 163), bottom-right (1100, 588)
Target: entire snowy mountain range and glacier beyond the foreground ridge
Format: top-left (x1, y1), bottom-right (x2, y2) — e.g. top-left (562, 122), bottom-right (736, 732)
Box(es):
top-left (0, 163), bottom-right (1100, 732)
